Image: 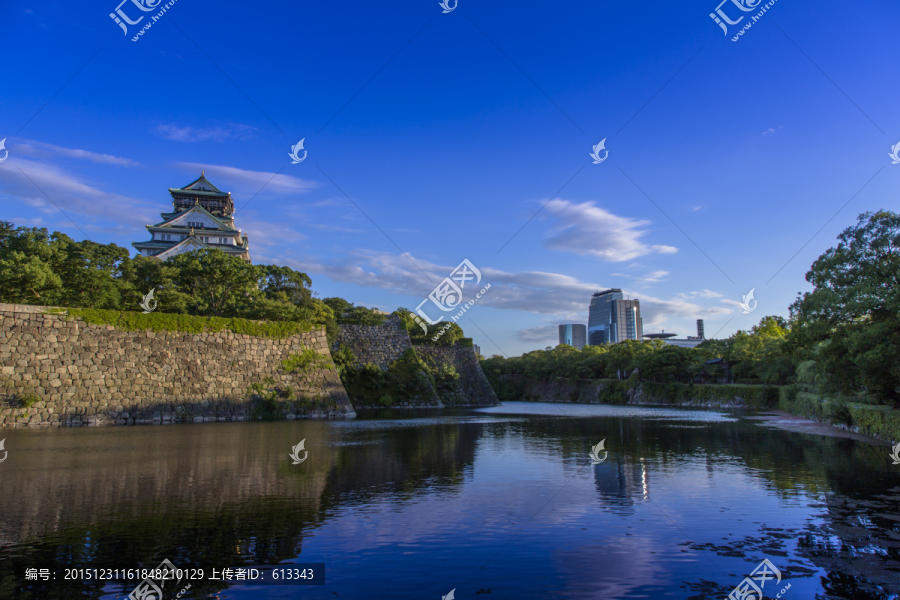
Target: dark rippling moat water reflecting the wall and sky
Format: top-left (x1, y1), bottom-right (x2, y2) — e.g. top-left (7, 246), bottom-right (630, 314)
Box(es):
top-left (0, 403), bottom-right (900, 600)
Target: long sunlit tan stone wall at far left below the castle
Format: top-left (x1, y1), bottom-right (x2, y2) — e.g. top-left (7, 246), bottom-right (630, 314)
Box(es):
top-left (0, 304), bottom-right (356, 426)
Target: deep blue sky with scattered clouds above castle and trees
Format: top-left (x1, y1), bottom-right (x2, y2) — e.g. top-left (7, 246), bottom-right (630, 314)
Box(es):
top-left (0, 0), bottom-right (900, 356)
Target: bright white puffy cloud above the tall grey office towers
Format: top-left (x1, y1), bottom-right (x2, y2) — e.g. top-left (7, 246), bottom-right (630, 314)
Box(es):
top-left (544, 199), bottom-right (678, 262)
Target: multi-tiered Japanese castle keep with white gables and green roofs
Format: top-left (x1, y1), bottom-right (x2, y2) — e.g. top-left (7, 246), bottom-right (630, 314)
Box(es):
top-left (131, 171), bottom-right (250, 262)
